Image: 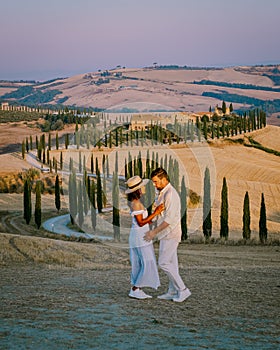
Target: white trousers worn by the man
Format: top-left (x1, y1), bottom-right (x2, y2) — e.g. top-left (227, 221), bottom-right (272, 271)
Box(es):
top-left (158, 239), bottom-right (186, 293)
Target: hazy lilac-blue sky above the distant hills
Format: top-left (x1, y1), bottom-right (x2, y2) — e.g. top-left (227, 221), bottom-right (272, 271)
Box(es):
top-left (0, 0), bottom-right (280, 80)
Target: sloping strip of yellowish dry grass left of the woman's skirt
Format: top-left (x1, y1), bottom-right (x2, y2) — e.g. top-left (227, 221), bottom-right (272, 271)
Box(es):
top-left (0, 233), bottom-right (129, 268)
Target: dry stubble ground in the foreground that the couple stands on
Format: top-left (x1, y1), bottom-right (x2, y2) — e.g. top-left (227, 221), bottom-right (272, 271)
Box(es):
top-left (0, 234), bottom-right (280, 349)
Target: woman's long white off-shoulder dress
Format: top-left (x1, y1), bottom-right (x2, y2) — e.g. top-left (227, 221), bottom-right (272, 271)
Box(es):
top-left (129, 209), bottom-right (160, 289)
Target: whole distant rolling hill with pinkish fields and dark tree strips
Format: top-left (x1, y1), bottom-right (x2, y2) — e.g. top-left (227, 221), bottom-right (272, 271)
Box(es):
top-left (0, 65), bottom-right (280, 125)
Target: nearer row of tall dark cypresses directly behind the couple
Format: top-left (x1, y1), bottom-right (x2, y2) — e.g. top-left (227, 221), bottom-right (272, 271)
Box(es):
top-left (23, 157), bottom-right (268, 243)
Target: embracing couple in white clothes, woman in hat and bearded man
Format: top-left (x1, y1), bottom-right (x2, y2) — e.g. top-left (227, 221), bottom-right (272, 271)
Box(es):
top-left (125, 168), bottom-right (191, 302)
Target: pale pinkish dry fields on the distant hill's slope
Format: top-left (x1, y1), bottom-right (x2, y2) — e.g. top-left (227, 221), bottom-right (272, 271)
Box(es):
top-left (36, 67), bottom-right (280, 117)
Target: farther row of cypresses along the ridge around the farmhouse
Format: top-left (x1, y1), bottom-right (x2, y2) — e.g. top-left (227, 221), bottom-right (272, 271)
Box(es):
top-left (22, 109), bottom-right (266, 160)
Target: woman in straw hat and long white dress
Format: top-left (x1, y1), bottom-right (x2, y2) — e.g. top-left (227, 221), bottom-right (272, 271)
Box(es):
top-left (125, 176), bottom-right (164, 299)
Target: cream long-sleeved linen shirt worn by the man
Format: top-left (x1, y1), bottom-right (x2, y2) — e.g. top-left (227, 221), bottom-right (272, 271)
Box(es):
top-left (155, 183), bottom-right (182, 242)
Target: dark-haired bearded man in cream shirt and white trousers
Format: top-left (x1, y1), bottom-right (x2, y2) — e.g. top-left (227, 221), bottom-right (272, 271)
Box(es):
top-left (144, 168), bottom-right (191, 302)
